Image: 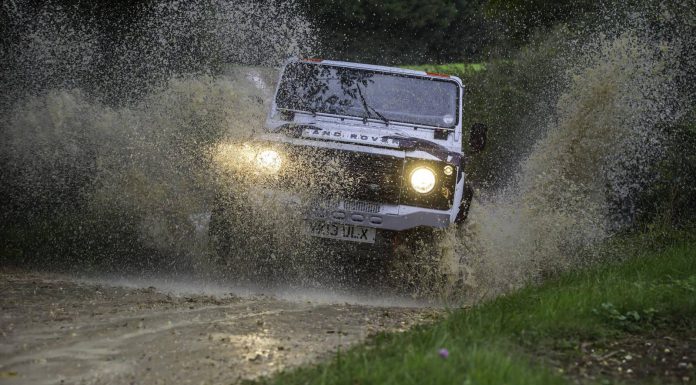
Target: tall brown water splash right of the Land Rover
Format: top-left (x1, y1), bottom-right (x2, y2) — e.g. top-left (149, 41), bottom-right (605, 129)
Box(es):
top-left (424, 31), bottom-right (680, 299)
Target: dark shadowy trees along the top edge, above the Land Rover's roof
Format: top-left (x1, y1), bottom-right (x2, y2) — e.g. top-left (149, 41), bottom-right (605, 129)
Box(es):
top-left (0, 0), bottom-right (604, 64)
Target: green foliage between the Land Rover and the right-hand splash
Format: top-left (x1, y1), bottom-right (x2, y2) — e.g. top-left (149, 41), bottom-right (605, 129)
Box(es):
top-left (408, 29), bottom-right (568, 187)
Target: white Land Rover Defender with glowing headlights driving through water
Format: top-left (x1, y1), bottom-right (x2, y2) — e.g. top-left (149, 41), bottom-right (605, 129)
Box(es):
top-left (211, 59), bottom-right (485, 268)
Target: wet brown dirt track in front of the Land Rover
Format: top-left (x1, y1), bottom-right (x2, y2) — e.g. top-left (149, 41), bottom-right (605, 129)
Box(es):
top-left (0, 271), bottom-right (438, 384)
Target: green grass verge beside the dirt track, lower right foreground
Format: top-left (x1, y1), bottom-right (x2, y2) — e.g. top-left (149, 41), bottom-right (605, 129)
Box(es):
top-left (250, 237), bottom-right (696, 385)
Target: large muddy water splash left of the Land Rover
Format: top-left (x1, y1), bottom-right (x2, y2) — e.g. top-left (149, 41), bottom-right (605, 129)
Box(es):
top-left (0, 0), bottom-right (314, 271)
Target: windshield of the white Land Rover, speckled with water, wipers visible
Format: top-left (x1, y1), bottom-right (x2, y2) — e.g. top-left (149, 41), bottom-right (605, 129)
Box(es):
top-left (276, 62), bottom-right (459, 128)
